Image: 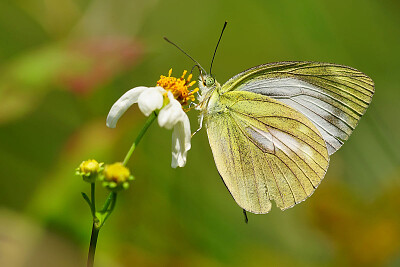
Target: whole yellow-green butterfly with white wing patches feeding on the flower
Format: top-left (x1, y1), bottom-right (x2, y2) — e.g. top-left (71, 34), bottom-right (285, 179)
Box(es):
top-left (199, 61), bottom-right (374, 214)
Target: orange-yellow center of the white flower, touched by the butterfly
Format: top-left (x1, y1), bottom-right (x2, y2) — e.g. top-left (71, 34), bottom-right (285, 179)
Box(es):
top-left (157, 69), bottom-right (199, 106)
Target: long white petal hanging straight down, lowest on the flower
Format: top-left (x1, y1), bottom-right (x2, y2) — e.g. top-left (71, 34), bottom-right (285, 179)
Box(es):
top-left (171, 113), bottom-right (191, 168)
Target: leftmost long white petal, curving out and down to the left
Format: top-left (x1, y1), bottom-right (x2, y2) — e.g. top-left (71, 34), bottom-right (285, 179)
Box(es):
top-left (106, 86), bottom-right (147, 128)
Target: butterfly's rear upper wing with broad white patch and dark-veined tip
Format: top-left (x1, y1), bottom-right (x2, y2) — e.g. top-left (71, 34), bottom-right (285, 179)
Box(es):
top-left (221, 62), bottom-right (374, 155)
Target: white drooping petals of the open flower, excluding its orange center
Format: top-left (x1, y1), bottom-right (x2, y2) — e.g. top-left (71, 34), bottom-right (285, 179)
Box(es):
top-left (106, 86), bottom-right (191, 168)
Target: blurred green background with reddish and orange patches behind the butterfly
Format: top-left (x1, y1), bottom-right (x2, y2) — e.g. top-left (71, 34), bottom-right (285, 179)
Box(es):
top-left (0, 0), bottom-right (400, 266)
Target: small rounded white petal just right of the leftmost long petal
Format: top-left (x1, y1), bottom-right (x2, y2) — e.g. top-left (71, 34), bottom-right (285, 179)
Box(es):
top-left (138, 87), bottom-right (165, 116)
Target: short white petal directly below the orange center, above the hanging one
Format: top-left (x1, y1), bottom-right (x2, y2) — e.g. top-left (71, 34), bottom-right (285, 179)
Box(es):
top-left (158, 92), bottom-right (186, 130)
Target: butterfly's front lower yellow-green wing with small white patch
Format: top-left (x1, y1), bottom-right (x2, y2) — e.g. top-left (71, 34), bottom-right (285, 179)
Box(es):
top-left (205, 91), bottom-right (329, 213)
